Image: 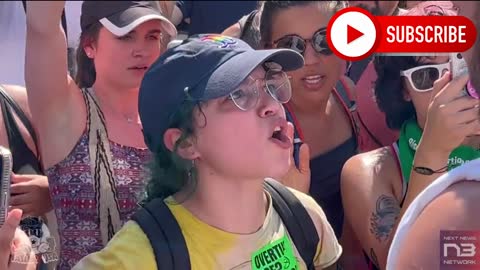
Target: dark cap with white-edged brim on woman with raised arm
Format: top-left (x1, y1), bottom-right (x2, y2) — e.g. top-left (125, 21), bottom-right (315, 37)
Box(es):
top-left (80, 1), bottom-right (177, 37)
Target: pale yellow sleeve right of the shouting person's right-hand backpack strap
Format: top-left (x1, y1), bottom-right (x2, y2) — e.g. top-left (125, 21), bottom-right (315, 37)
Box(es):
top-left (289, 188), bottom-right (342, 269)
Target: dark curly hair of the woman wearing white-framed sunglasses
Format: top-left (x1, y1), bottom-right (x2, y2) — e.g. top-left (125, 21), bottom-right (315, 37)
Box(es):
top-left (373, 55), bottom-right (422, 130)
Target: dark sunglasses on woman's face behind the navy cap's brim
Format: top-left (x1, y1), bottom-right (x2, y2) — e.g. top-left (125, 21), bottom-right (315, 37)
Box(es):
top-left (273, 28), bottom-right (332, 56)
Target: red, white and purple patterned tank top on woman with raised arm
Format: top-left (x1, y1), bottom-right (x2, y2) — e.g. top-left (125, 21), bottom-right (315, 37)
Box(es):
top-left (46, 89), bottom-right (151, 270)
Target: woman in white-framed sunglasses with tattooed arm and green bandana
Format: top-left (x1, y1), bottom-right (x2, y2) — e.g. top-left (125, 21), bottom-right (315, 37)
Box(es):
top-left (342, 50), bottom-right (480, 269)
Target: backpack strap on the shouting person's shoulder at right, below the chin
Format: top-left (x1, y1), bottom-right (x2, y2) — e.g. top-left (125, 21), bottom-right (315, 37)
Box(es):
top-left (265, 179), bottom-right (320, 270)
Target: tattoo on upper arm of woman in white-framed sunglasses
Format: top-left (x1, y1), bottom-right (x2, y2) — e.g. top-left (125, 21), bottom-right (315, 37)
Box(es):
top-left (370, 195), bottom-right (400, 242)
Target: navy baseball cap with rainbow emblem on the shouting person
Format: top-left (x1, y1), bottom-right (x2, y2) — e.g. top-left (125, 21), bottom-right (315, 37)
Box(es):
top-left (138, 34), bottom-right (304, 152)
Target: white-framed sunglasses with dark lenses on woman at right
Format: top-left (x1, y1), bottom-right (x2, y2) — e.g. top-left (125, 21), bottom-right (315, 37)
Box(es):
top-left (400, 61), bottom-right (450, 92)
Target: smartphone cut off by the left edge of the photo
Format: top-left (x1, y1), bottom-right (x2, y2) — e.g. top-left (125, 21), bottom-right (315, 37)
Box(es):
top-left (0, 146), bottom-right (12, 226)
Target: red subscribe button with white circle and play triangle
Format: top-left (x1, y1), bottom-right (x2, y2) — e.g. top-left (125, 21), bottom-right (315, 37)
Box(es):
top-left (327, 7), bottom-right (477, 61)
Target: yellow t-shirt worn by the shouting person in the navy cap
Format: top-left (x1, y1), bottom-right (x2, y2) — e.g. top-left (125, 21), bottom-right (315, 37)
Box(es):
top-left (73, 189), bottom-right (342, 270)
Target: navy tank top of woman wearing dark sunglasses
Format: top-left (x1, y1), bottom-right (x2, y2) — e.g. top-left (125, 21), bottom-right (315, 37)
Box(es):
top-left (285, 85), bottom-right (358, 238)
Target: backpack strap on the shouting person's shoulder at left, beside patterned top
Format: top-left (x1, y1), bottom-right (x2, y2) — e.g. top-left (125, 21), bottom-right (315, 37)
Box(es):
top-left (132, 199), bottom-right (191, 270)
